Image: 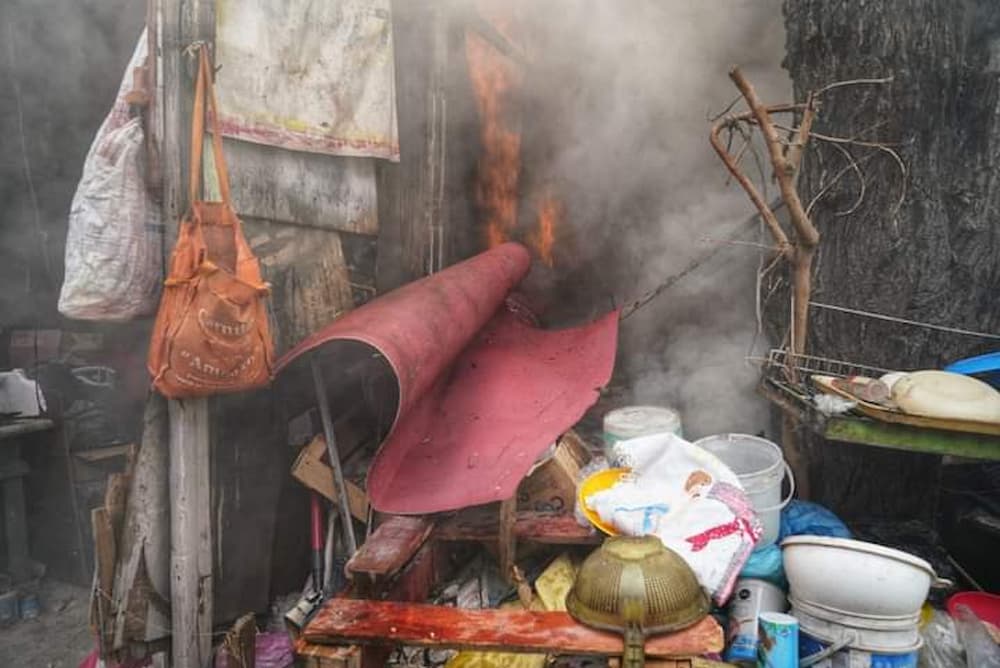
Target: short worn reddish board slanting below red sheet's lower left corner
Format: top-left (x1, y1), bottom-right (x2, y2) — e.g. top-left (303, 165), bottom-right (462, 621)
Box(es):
top-left (347, 515), bottom-right (434, 579)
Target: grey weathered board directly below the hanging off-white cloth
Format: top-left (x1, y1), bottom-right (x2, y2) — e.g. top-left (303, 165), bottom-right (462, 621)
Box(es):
top-left (221, 139), bottom-right (378, 235)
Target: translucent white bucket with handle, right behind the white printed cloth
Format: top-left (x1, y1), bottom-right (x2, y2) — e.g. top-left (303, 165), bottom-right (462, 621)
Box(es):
top-left (694, 434), bottom-right (795, 548)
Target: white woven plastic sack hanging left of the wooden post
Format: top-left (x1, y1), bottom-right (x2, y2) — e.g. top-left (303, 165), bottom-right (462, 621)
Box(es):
top-left (59, 31), bottom-right (163, 320)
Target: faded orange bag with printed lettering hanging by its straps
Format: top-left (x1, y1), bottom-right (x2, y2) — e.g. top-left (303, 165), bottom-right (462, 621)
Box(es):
top-left (147, 47), bottom-right (274, 399)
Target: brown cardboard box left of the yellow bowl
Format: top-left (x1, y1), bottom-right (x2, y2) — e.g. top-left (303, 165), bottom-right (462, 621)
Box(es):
top-left (517, 431), bottom-right (590, 513)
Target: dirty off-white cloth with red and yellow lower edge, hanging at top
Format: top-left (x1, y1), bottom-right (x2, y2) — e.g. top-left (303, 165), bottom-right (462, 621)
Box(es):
top-left (216, 0), bottom-right (399, 161)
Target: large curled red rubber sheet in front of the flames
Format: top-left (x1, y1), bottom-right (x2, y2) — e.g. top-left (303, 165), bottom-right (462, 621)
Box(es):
top-left (277, 243), bottom-right (618, 514)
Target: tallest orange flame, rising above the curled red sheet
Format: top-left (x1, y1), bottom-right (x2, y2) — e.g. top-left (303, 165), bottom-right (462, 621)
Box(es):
top-left (465, 8), bottom-right (521, 248)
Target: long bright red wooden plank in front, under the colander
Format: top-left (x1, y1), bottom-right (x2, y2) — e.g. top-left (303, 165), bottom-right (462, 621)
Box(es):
top-left (302, 599), bottom-right (723, 657)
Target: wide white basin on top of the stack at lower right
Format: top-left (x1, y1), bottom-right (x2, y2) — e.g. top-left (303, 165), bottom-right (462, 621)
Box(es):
top-left (781, 536), bottom-right (936, 619)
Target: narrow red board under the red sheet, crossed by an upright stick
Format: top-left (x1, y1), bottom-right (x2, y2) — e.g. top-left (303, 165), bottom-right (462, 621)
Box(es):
top-left (434, 511), bottom-right (603, 545)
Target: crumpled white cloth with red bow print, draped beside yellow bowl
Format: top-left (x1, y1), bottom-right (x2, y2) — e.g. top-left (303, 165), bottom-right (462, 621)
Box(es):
top-left (584, 433), bottom-right (763, 605)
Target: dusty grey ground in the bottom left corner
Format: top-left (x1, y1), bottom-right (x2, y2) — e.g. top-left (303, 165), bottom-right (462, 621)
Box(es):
top-left (0, 579), bottom-right (93, 668)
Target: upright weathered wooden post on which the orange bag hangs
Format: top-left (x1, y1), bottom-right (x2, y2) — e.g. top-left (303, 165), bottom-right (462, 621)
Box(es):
top-left (154, 0), bottom-right (215, 668)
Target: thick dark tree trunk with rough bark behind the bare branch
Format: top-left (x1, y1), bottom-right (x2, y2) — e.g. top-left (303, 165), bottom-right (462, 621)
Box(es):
top-left (769, 0), bottom-right (1000, 518)
